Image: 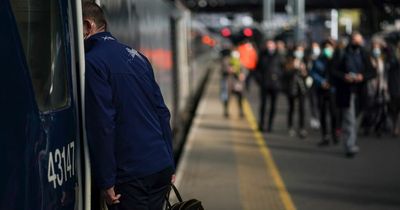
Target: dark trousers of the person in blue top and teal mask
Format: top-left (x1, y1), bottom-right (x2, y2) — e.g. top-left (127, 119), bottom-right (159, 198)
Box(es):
top-left (318, 90), bottom-right (337, 138)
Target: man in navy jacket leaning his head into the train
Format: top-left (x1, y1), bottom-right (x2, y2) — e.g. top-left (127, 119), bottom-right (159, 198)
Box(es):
top-left (82, 2), bottom-right (175, 210)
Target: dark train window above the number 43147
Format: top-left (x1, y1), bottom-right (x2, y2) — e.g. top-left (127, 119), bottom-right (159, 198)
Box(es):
top-left (11, 0), bottom-right (68, 112)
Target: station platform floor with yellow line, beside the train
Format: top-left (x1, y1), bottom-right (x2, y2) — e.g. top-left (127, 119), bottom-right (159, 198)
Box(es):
top-left (176, 65), bottom-right (400, 210)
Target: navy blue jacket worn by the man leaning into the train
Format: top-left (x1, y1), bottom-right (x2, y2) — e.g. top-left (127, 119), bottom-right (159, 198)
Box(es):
top-left (85, 32), bottom-right (174, 189)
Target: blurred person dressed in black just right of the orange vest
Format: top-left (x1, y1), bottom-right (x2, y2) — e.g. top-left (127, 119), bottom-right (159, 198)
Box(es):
top-left (256, 40), bottom-right (283, 132)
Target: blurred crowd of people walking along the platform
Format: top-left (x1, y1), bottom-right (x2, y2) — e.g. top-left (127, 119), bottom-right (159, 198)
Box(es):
top-left (220, 32), bottom-right (400, 157)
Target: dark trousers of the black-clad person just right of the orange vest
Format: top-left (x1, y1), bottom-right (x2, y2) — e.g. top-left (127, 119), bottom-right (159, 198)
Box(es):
top-left (258, 89), bottom-right (278, 131)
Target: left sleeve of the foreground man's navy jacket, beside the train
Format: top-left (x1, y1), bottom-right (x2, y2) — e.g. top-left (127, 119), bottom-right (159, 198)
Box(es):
top-left (85, 59), bottom-right (116, 189)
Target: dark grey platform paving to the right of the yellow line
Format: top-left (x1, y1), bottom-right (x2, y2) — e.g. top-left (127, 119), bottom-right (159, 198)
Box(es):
top-left (247, 79), bottom-right (400, 210)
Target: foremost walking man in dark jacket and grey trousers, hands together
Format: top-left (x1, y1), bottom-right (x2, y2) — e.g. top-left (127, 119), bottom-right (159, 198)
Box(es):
top-left (331, 32), bottom-right (376, 157)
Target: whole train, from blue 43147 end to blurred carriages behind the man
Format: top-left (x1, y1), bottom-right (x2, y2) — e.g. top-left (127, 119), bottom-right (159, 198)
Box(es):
top-left (0, 0), bottom-right (217, 210)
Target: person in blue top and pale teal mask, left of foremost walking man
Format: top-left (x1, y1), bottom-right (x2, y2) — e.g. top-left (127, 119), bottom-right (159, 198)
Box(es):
top-left (311, 41), bottom-right (338, 146)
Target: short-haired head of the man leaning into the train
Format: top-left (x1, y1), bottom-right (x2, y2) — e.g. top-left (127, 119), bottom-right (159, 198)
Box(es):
top-left (82, 1), bottom-right (107, 39)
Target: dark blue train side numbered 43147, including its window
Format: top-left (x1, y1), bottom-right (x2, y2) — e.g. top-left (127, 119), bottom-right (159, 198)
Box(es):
top-left (0, 0), bottom-right (79, 210)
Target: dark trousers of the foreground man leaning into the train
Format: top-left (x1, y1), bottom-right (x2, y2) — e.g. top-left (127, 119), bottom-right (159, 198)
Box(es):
top-left (108, 167), bottom-right (173, 210)
